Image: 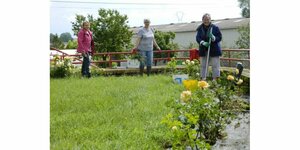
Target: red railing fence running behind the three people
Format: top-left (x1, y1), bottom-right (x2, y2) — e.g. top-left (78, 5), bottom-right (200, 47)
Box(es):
top-left (50, 48), bottom-right (250, 69)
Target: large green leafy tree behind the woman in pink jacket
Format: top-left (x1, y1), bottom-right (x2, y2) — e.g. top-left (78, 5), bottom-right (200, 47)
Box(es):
top-left (72, 9), bottom-right (133, 66)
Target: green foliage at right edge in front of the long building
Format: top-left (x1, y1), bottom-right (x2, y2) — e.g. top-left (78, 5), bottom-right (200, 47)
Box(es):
top-left (235, 23), bottom-right (250, 49)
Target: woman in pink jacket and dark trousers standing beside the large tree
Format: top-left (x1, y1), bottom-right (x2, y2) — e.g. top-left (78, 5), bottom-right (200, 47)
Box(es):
top-left (77, 21), bottom-right (94, 78)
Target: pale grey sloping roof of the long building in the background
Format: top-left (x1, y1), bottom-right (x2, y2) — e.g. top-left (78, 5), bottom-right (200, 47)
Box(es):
top-left (131, 18), bottom-right (250, 33)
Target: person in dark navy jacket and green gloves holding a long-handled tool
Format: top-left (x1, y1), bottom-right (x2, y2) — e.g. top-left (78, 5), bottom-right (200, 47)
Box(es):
top-left (196, 13), bottom-right (222, 80)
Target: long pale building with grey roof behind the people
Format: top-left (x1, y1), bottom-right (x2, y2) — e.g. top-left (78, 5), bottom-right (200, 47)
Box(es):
top-left (131, 18), bottom-right (250, 49)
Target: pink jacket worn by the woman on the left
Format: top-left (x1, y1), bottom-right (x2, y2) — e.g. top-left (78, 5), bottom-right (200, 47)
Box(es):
top-left (77, 29), bottom-right (94, 53)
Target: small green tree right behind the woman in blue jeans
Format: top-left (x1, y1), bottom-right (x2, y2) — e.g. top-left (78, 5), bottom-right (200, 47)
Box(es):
top-left (154, 30), bottom-right (179, 58)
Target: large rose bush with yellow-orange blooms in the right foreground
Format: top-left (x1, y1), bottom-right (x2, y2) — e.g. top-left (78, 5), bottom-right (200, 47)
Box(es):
top-left (161, 70), bottom-right (250, 149)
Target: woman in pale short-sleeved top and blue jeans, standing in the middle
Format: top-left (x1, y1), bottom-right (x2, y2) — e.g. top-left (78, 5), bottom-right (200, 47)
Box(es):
top-left (134, 19), bottom-right (161, 76)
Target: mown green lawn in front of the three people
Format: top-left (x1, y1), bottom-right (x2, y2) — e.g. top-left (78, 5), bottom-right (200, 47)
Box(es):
top-left (50, 75), bottom-right (184, 150)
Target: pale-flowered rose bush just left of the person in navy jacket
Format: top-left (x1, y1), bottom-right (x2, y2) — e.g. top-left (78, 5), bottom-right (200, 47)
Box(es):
top-left (182, 59), bottom-right (200, 79)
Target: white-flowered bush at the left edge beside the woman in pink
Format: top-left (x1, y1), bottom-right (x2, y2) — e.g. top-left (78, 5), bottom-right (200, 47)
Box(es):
top-left (50, 55), bottom-right (74, 78)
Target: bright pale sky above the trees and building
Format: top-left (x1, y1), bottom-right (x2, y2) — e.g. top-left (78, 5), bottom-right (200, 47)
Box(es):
top-left (50, 0), bottom-right (241, 35)
